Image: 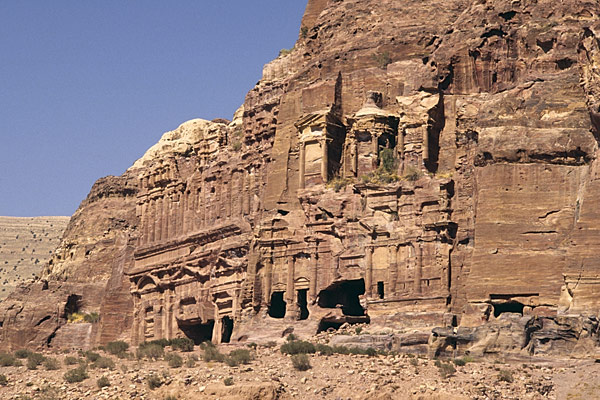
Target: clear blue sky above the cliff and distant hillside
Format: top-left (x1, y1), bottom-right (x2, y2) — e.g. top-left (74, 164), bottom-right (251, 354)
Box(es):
top-left (0, 0), bottom-right (306, 216)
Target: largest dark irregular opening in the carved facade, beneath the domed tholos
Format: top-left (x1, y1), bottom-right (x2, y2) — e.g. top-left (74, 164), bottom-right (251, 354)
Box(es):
top-left (319, 279), bottom-right (365, 316)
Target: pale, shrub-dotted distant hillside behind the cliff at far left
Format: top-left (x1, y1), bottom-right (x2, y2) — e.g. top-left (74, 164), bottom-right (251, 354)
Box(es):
top-left (0, 217), bottom-right (70, 299)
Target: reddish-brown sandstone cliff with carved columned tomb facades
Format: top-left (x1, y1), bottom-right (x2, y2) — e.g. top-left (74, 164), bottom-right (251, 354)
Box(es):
top-left (0, 0), bottom-right (600, 353)
